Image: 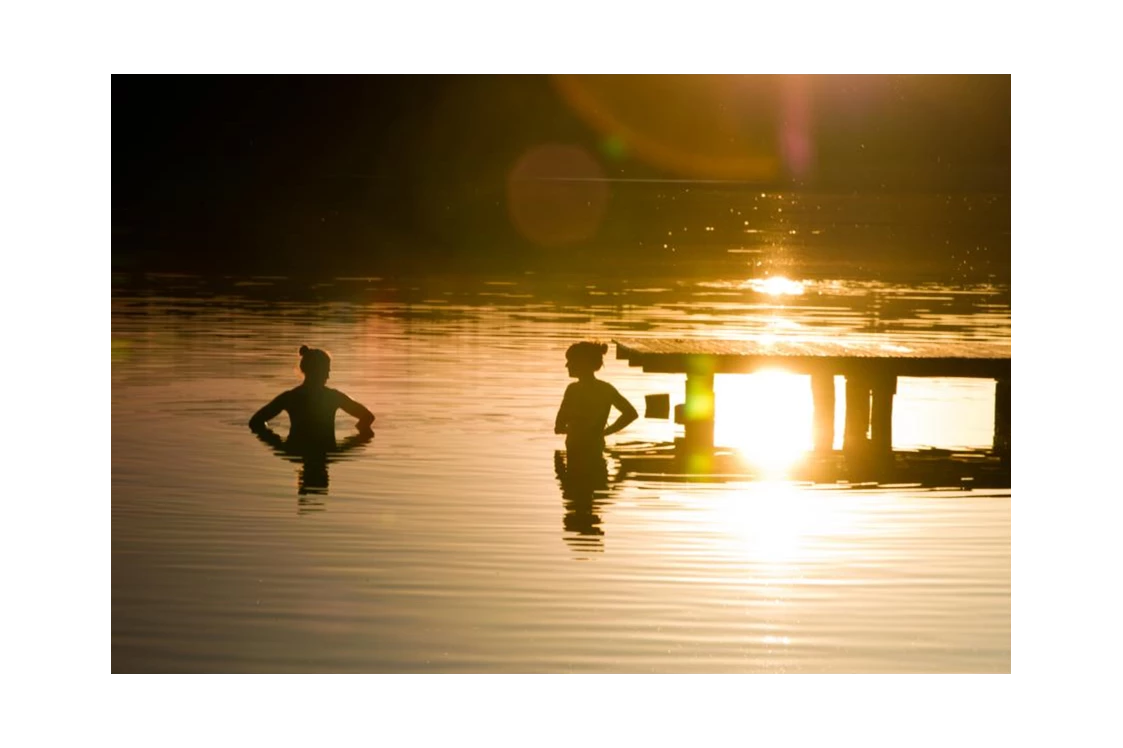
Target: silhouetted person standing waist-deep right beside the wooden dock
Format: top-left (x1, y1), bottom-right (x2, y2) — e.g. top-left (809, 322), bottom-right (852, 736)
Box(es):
top-left (554, 341), bottom-right (639, 451)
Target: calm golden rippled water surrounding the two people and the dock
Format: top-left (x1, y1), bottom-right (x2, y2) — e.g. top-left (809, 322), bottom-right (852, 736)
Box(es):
top-left (110, 270), bottom-right (1011, 673)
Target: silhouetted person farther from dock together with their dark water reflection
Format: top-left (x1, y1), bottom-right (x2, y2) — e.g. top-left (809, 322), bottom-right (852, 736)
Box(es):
top-left (249, 346), bottom-right (374, 507)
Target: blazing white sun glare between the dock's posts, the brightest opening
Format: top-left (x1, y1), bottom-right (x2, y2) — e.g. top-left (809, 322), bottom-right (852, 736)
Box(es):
top-left (713, 371), bottom-right (812, 477)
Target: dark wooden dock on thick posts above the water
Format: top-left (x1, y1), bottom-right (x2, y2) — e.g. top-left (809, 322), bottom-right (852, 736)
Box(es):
top-left (613, 338), bottom-right (1011, 458)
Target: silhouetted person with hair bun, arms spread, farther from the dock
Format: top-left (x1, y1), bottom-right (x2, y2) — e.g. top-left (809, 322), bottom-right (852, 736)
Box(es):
top-left (249, 346), bottom-right (374, 446)
